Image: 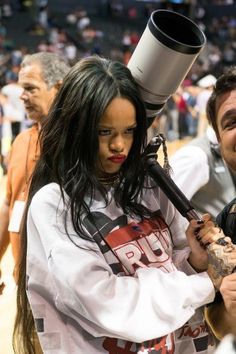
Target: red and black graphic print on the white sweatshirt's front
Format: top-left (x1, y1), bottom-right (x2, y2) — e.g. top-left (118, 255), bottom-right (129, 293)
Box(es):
top-left (83, 210), bottom-right (214, 354)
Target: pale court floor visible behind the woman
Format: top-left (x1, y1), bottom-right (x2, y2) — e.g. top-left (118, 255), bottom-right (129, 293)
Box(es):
top-left (0, 140), bottom-right (188, 354)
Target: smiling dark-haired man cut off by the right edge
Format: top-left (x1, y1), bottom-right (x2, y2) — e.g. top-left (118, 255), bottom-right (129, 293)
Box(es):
top-left (202, 67), bottom-right (236, 339)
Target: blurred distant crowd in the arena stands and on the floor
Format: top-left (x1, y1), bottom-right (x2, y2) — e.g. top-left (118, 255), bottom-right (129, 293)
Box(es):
top-left (0, 0), bottom-right (236, 173)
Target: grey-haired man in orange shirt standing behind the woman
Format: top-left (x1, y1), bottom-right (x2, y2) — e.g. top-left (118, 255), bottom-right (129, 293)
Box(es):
top-left (0, 53), bottom-right (69, 281)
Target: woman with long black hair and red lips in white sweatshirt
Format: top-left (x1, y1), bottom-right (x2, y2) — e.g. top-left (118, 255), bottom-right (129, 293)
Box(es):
top-left (15, 56), bottom-right (229, 354)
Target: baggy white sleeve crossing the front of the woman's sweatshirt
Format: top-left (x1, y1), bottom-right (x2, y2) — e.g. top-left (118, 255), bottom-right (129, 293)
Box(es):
top-left (27, 185), bottom-right (215, 342)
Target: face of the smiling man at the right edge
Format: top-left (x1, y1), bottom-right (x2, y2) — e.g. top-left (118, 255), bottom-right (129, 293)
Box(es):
top-left (217, 90), bottom-right (236, 171)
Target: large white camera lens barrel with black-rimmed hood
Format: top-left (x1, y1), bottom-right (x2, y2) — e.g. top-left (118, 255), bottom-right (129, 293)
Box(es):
top-left (128, 10), bottom-right (206, 117)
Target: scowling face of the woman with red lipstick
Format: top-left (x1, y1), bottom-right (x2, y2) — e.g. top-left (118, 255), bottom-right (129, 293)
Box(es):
top-left (97, 97), bottom-right (137, 174)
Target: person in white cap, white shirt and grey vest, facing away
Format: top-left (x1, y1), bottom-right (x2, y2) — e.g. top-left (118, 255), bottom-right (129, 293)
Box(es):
top-left (170, 75), bottom-right (236, 224)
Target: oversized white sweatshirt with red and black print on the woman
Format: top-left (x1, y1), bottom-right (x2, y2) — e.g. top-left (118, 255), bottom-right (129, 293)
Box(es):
top-left (27, 183), bottom-right (215, 354)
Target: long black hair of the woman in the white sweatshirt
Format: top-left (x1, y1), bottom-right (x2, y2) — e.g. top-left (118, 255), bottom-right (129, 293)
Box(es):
top-left (13, 56), bottom-right (148, 354)
